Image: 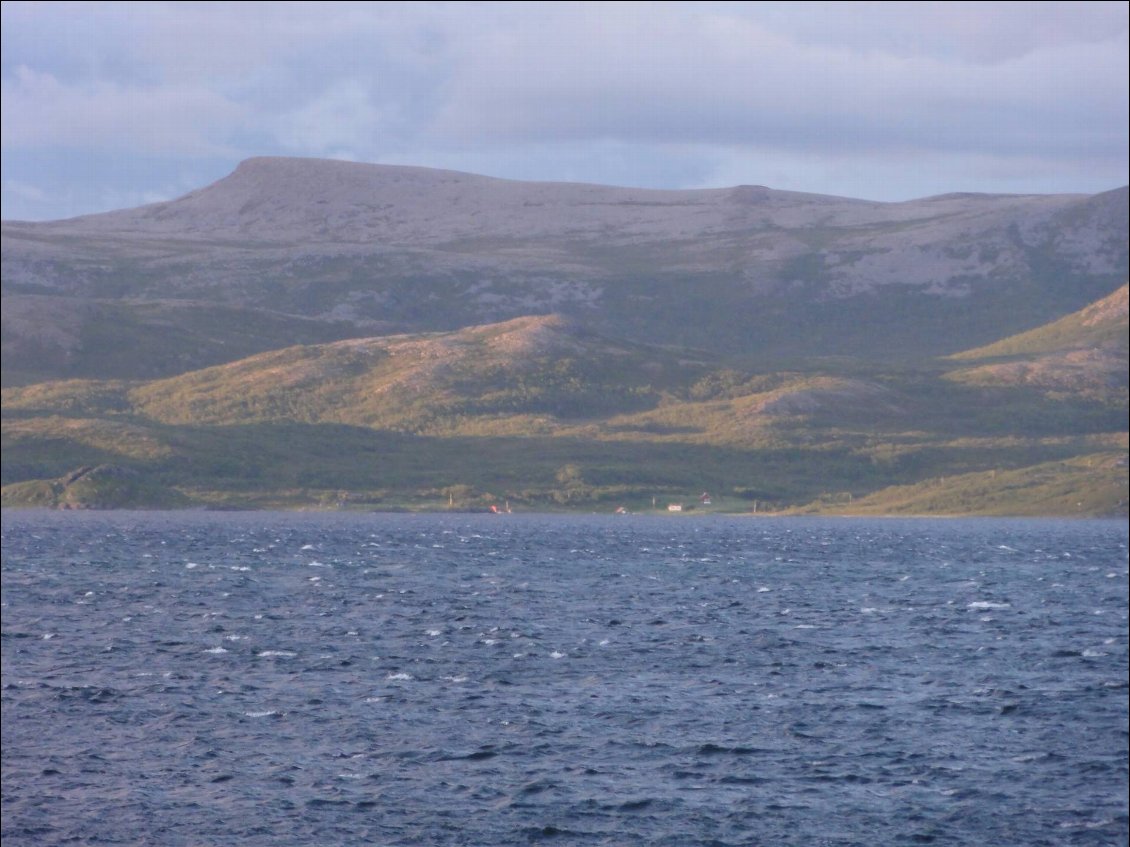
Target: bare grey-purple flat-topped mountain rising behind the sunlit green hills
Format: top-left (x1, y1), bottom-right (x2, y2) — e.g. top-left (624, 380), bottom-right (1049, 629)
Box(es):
top-left (2, 158), bottom-right (1130, 385)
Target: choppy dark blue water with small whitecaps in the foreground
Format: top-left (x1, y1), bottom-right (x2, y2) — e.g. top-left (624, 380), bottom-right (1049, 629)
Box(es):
top-left (2, 512), bottom-right (1128, 847)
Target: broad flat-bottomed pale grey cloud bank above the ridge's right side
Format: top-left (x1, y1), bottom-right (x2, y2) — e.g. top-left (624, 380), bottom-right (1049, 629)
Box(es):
top-left (427, 5), bottom-right (1128, 163)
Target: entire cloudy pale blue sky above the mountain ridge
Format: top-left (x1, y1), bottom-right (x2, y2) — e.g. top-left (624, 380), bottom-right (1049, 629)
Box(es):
top-left (0, 0), bottom-right (1130, 220)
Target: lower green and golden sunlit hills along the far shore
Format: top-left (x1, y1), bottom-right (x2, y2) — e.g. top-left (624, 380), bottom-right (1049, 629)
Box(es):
top-left (2, 304), bottom-right (1127, 515)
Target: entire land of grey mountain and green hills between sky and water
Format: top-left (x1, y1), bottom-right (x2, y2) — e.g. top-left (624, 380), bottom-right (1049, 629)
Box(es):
top-left (2, 158), bottom-right (1128, 515)
